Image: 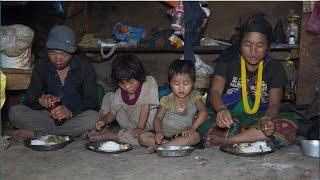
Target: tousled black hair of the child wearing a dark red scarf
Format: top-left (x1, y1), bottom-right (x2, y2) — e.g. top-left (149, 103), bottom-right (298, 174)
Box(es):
top-left (111, 54), bottom-right (146, 84)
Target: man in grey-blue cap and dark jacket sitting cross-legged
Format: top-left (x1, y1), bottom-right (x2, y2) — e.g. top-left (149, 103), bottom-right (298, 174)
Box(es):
top-left (9, 26), bottom-right (99, 142)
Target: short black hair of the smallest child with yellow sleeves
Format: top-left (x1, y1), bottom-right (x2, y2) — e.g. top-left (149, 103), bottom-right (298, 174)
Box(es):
top-left (168, 59), bottom-right (196, 83)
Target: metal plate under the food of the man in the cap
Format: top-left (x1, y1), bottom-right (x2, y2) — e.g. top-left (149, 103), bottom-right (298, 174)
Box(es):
top-left (23, 136), bottom-right (73, 151)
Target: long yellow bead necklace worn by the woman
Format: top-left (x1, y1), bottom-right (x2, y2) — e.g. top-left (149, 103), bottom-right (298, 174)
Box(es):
top-left (240, 56), bottom-right (263, 114)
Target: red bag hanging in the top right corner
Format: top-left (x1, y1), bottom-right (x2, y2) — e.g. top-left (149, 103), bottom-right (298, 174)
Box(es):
top-left (306, 2), bottom-right (320, 35)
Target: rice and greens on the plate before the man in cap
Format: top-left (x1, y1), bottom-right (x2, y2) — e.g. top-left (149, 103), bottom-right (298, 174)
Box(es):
top-left (31, 135), bottom-right (70, 146)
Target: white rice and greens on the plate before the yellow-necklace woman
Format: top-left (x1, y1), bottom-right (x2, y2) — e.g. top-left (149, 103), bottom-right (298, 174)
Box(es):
top-left (233, 141), bottom-right (272, 153)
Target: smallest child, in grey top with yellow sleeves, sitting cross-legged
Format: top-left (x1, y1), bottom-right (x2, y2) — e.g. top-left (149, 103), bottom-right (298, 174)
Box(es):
top-left (139, 60), bottom-right (208, 149)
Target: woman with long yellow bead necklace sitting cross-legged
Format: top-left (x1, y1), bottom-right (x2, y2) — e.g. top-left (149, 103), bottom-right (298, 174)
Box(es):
top-left (204, 13), bottom-right (298, 149)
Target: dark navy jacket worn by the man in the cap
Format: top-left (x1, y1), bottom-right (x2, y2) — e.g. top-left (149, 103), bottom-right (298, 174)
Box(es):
top-left (24, 55), bottom-right (98, 116)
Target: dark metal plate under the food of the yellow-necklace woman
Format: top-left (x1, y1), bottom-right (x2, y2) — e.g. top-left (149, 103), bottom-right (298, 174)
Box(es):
top-left (220, 141), bottom-right (275, 157)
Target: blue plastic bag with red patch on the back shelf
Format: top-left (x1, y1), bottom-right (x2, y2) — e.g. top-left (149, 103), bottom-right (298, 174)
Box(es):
top-left (113, 23), bottom-right (147, 42)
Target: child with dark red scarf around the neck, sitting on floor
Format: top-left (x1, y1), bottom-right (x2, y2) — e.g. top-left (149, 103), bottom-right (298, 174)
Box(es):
top-left (89, 54), bottom-right (159, 145)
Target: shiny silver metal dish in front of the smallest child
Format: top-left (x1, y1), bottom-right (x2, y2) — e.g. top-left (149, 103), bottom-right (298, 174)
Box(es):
top-left (155, 146), bottom-right (194, 157)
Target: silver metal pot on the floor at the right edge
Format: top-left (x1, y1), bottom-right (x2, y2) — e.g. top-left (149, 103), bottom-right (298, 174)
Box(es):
top-left (300, 140), bottom-right (320, 157)
